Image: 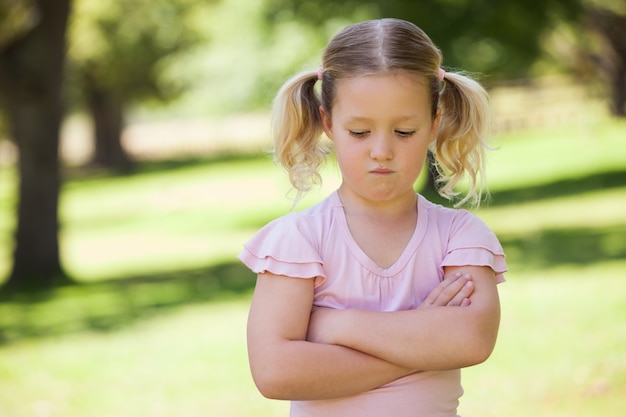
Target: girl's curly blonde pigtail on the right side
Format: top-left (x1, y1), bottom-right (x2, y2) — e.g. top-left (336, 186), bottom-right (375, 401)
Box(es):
top-left (432, 72), bottom-right (491, 207)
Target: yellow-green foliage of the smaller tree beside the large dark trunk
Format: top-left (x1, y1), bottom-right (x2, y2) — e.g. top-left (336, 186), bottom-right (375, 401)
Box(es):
top-left (69, 0), bottom-right (201, 103)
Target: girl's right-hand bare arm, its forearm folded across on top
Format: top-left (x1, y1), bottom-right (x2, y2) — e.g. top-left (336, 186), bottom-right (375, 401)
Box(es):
top-left (309, 266), bottom-right (500, 371)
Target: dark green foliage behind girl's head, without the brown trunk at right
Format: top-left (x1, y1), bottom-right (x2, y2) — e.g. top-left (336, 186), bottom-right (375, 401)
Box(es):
top-left (267, 0), bottom-right (580, 78)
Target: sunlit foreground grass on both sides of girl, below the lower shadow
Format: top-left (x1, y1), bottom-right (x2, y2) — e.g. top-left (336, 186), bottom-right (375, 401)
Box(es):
top-left (0, 261), bottom-right (626, 417)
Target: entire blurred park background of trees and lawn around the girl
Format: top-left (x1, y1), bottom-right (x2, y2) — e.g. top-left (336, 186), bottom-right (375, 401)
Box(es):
top-left (0, 0), bottom-right (626, 417)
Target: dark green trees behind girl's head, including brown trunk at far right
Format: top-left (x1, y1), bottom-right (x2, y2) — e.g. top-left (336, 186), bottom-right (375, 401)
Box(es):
top-left (267, 0), bottom-right (626, 117)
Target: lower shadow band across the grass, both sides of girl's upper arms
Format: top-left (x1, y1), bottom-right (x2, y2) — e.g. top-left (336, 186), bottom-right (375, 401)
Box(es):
top-left (0, 225), bottom-right (626, 344)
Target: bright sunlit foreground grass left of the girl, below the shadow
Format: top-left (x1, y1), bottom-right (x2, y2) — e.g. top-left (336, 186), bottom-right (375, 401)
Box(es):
top-left (0, 301), bottom-right (288, 417)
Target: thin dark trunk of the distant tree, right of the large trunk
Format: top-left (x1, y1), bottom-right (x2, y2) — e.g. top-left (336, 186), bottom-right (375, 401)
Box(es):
top-left (83, 75), bottom-right (133, 173)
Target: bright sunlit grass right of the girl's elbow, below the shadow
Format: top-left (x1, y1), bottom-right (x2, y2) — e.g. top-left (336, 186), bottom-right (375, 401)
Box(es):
top-left (461, 260), bottom-right (626, 417)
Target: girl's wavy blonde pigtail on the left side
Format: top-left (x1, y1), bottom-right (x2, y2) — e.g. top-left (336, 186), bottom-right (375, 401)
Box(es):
top-left (272, 71), bottom-right (329, 202)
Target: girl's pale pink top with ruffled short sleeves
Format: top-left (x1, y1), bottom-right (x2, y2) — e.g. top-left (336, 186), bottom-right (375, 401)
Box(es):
top-left (239, 192), bottom-right (507, 417)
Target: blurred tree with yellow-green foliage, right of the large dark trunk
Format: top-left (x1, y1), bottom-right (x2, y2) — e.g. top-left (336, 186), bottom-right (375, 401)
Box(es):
top-left (69, 0), bottom-right (206, 172)
